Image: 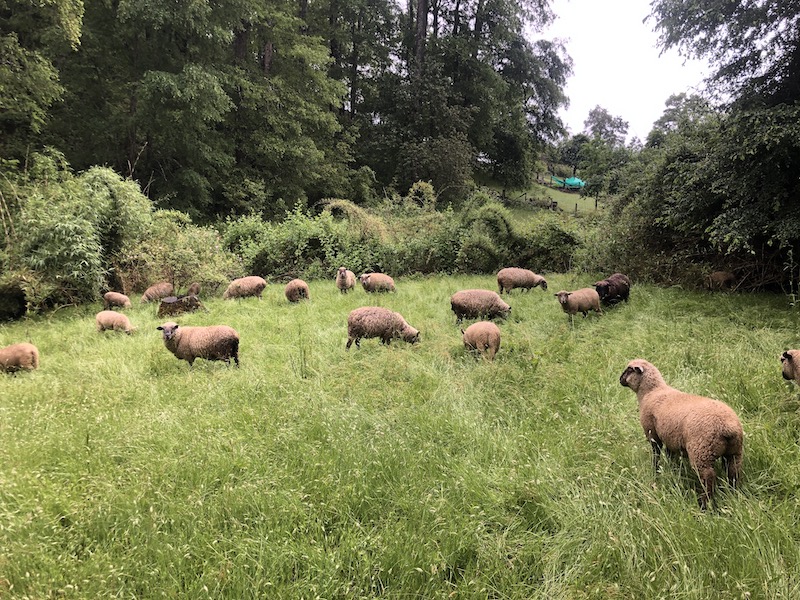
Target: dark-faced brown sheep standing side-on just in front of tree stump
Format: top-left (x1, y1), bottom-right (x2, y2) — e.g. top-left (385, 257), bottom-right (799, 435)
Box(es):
top-left (156, 321), bottom-right (239, 367)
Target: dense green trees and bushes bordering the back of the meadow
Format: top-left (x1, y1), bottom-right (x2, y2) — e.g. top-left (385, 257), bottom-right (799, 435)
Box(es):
top-left (0, 0), bottom-right (800, 306)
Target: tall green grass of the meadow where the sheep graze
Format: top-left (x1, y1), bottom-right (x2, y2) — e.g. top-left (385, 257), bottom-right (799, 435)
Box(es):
top-left (0, 274), bottom-right (800, 599)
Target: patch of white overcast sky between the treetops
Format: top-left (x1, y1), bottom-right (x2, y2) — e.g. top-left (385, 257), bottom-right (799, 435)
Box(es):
top-left (535, 0), bottom-right (708, 141)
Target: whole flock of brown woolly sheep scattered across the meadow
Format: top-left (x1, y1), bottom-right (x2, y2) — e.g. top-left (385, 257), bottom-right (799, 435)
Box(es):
top-left (0, 267), bottom-right (800, 509)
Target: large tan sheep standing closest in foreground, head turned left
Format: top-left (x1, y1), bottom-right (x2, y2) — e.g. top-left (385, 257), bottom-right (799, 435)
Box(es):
top-left (619, 359), bottom-right (744, 510)
